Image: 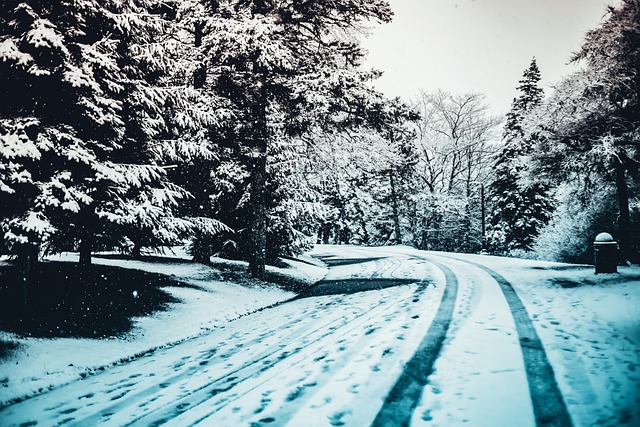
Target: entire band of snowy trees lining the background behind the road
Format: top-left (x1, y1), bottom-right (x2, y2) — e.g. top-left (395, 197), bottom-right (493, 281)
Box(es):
top-left (0, 0), bottom-right (640, 278)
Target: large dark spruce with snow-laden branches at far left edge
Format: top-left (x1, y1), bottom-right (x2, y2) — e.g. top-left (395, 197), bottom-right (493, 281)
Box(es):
top-left (0, 1), bottom-right (210, 274)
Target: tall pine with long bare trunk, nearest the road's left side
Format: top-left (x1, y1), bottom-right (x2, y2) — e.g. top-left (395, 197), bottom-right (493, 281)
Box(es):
top-left (198, 0), bottom-right (412, 277)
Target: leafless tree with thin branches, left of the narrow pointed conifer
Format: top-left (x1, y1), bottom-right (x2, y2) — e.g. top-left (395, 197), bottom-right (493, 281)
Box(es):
top-left (413, 91), bottom-right (501, 251)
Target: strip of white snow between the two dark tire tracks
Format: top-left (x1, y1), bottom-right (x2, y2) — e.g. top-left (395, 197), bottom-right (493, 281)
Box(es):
top-left (412, 256), bottom-right (535, 427)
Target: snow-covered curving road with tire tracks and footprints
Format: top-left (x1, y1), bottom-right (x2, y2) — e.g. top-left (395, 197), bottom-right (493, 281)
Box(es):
top-left (0, 246), bottom-right (640, 426)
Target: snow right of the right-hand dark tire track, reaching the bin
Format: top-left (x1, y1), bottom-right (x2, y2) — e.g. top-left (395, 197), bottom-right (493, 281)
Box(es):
top-left (390, 250), bottom-right (640, 426)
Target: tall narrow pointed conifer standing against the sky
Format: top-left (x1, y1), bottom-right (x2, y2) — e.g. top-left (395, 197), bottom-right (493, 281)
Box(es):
top-left (487, 58), bottom-right (553, 253)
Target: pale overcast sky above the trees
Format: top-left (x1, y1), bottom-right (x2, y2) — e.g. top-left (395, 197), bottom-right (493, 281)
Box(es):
top-left (364, 0), bottom-right (619, 114)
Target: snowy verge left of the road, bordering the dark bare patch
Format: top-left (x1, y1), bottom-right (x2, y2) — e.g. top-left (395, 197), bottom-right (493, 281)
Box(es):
top-left (0, 252), bottom-right (327, 406)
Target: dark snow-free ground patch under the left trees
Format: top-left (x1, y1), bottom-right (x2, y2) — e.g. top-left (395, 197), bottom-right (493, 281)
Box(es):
top-left (0, 262), bottom-right (193, 338)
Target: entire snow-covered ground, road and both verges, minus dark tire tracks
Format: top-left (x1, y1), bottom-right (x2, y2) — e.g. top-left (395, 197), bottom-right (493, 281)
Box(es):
top-left (0, 246), bottom-right (640, 426)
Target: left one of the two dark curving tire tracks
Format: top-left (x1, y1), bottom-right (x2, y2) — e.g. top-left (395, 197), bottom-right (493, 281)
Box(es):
top-left (372, 260), bottom-right (458, 427)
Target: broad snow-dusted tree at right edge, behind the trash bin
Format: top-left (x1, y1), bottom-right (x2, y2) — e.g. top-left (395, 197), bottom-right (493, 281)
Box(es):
top-left (530, 0), bottom-right (640, 261)
